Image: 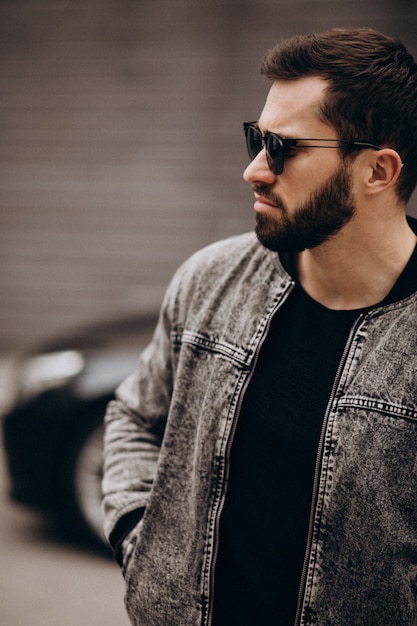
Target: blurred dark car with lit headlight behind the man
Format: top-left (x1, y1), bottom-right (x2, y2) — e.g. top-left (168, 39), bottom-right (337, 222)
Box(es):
top-left (3, 315), bottom-right (156, 546)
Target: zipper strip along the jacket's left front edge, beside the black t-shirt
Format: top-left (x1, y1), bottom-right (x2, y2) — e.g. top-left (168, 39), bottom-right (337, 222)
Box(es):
top-left (205, 281), bottom-right (295, 626)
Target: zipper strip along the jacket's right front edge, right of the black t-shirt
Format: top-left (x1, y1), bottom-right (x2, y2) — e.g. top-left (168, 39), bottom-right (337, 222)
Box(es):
top-left (294, 314), bottom-right (365, 626)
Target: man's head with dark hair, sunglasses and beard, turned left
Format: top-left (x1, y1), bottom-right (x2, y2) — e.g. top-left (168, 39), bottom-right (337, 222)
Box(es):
top-left (244, 29), bottom-right (417, 250)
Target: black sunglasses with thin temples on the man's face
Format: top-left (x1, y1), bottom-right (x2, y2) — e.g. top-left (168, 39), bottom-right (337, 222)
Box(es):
top-left (243, 122), bottom-right (382, 175)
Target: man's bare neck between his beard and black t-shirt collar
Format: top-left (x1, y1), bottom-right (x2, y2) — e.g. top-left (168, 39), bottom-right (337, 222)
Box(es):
top-left (296, 215), bottom-right (416, 310)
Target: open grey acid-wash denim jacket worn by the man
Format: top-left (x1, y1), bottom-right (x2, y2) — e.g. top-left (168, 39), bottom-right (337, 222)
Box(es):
top-left (103, 234), bottom-right (417, 626)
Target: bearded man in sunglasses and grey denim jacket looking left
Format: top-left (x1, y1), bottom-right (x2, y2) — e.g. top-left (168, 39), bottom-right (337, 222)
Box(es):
top-left (103, 29), bottom-right (417, 626)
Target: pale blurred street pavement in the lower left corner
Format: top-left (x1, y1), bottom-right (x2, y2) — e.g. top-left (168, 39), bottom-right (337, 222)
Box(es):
top-left (0, 441), bottom-right (130, 626)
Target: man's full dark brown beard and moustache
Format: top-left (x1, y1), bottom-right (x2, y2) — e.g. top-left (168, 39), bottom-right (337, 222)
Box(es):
top-left (253, 164), bottom-right (355, 252)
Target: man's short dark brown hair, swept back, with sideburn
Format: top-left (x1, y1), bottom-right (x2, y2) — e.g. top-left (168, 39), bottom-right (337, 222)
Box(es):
top-left (261, 28), bottom-right (417, 202)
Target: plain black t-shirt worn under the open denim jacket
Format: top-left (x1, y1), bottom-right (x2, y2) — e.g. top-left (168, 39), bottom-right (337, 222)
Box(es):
top-left (213, 244), bottom-right (417, 626)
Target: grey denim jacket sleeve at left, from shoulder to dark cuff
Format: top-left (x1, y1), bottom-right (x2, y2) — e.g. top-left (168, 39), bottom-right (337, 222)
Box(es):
top-left (103, 233), bottom-right (250, 547)
